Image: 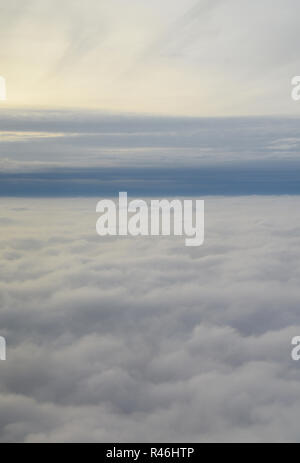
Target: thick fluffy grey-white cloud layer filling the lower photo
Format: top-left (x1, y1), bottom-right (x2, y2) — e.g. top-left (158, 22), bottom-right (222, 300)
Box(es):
top-left (0, 197), bottom-right (300, 442)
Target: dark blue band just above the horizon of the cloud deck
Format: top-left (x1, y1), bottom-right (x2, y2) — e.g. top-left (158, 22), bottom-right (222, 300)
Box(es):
top-left (0, 162), bottom-right (300, 197)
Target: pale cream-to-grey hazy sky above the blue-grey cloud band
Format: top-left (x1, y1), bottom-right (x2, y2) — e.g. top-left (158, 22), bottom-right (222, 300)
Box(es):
top-left (0, 0), bottom-right (300, 116)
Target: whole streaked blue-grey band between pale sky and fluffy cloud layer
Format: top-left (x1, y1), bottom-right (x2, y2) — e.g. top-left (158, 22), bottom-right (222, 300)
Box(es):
top-left (0, 111), bottom-right (300, 196)
